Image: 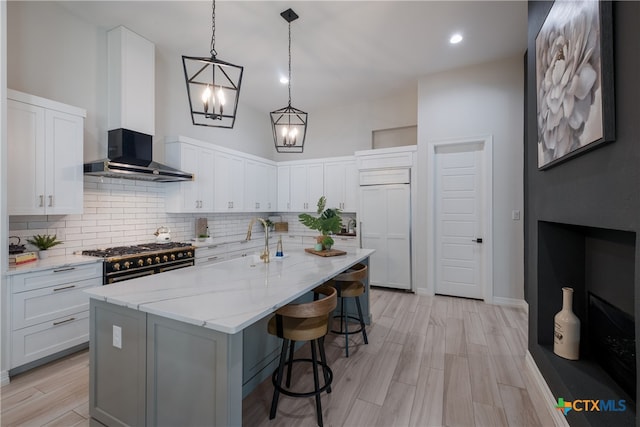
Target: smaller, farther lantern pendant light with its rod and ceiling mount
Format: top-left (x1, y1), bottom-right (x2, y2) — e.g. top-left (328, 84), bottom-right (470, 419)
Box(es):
top-left (270, 9), bottom-right (307, 153)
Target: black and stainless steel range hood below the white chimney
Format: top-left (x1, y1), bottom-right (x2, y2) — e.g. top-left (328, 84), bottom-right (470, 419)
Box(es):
top-left (84, 129), bottom-right (193, 182)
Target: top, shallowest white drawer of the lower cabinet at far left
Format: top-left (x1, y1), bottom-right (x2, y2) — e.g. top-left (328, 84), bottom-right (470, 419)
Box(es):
top-left (9, 262), bottom-right (102, 293)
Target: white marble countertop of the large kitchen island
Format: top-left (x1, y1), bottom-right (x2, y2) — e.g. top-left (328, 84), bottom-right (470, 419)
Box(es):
top-left (85, 246), bottom-right (374, 334)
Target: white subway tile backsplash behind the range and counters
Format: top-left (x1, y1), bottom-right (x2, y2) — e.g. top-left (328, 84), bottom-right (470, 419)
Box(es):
top-left (9, 176), bottom-right (304, 255)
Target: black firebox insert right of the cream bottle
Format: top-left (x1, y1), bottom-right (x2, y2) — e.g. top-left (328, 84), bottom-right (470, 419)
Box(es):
top-left (587, 292), bottom-right (636, 402)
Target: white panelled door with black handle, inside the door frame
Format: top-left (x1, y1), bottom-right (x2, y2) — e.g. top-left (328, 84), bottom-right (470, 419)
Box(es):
top-left (434, 144), bottom-right (485, 299)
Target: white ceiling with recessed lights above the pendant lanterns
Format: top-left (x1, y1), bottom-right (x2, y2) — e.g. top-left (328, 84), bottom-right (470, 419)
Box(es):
top-left (60, 0), bottom-right (527, 112)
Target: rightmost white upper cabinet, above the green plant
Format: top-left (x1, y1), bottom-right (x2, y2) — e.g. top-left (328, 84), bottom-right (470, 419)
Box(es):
top-left (324, 159), bottom-right (359, 212)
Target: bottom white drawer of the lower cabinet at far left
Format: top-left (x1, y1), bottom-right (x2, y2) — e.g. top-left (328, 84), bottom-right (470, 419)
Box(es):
top-left (11, 310), bottom-right (89, 368)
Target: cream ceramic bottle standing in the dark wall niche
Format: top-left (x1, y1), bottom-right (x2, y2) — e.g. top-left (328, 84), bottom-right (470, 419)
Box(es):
top-left (553, 288), bottom-right (580, 360)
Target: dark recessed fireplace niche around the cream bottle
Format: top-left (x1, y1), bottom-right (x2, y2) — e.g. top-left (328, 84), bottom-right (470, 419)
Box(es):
top-left (537, 221), bottom-right (636, 407)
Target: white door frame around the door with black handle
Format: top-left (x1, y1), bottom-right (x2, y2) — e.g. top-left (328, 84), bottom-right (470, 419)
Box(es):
top-left (426, 135), bottom-right (493, 304)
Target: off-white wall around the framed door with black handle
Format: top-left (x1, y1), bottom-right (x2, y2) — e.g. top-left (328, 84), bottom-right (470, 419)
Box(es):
top-left (415, 57), bottom-right (524, 300)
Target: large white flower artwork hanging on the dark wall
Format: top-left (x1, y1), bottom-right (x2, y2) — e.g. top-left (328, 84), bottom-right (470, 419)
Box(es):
top-left (536, 0), bottom-right (604, 168)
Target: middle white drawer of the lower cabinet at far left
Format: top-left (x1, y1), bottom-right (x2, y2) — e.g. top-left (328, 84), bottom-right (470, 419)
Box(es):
top-left (11, 279), bottom-right (102, 331)
